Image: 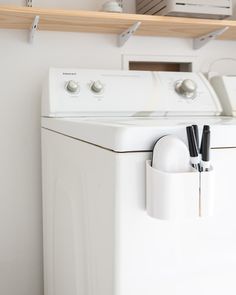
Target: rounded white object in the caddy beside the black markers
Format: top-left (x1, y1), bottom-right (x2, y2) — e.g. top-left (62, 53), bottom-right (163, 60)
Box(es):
top-left (152, 135), bottom-right (191, 173)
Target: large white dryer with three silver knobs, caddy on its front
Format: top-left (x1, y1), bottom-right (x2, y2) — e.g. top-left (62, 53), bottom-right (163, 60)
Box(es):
top-left (42, 69), bottom-right (236, 295)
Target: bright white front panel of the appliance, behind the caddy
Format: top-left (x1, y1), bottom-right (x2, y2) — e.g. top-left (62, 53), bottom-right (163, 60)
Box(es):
top-left (117, 148), bottom-right (236, 295)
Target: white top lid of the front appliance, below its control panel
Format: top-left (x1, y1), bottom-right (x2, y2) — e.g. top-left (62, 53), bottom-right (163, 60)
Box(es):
top-left (42, 117), bottom-right (236, 152)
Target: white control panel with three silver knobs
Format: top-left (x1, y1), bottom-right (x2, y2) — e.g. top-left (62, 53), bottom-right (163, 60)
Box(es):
top-left (42, 69), bottom-right (221, 117)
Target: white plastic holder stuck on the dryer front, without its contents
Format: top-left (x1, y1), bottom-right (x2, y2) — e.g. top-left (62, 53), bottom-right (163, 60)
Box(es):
top-left (146, 160), bottom-right (214, 220)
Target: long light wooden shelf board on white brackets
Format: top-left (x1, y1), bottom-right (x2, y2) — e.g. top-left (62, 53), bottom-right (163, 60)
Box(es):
top-left (0, 5), bottom-right (236, 40)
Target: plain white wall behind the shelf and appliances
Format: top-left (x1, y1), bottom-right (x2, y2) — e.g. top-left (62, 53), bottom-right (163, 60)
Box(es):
top-left (0, 0), bottom-right (236, 295)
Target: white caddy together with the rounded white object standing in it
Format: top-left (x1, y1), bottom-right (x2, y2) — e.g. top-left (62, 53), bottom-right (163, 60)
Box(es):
top-left (146, 136), bottom-right (215, 220)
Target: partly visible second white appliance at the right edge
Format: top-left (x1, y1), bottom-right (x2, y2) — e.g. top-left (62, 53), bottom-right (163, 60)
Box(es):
top-left (211, 76), bottom-right (236, 116)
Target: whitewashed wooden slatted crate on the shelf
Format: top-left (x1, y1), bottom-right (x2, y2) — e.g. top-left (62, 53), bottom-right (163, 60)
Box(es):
top-left (136, 0), bottom-right (232, 19)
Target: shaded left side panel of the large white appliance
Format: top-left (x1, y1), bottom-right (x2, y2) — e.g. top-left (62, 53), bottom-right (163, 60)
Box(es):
top-left (42, 129), bottom-right (115, 295)
